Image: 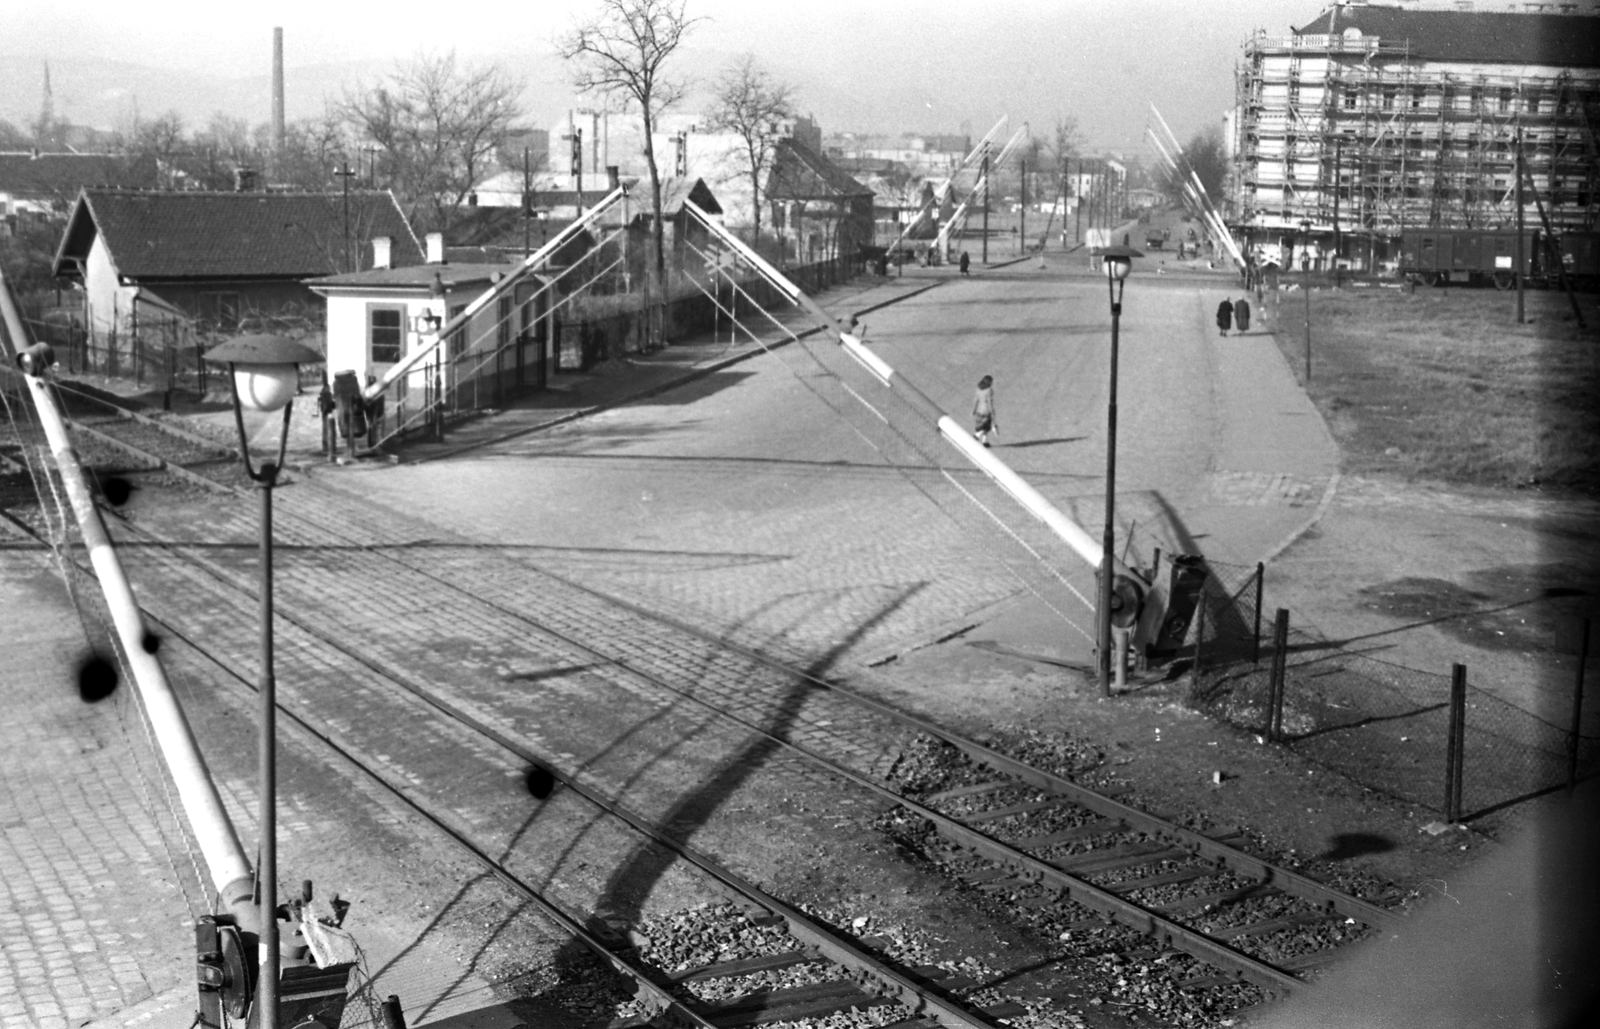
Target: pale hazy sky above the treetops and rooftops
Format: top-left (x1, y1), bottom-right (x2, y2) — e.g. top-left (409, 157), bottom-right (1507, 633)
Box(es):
top-left (0, 0), bottom-right (1323, 154)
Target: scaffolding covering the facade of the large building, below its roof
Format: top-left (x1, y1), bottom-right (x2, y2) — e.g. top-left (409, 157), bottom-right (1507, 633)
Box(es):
top-left (1229, 32), bottom-right (1600, 269)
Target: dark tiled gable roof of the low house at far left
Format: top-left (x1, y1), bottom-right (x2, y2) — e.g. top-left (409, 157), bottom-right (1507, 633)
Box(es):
top-left (56, 189), bottom-right (422, 282)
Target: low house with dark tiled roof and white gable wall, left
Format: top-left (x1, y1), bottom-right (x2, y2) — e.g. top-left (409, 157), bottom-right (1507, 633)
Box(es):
top-left (54, 189), bottom-right (422, 336)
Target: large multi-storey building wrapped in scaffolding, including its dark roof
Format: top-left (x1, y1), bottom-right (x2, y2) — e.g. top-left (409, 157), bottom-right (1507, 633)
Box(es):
top-left (1227, 0), bottom-right (1600, 270)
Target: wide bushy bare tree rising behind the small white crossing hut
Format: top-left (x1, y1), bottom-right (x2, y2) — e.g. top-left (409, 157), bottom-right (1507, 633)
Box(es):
top-left (341, 51), bottom-right (523, 227)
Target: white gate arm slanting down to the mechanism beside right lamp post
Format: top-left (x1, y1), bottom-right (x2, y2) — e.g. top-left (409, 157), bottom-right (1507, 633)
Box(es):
top-left (685, 200), bottom-right (1147, 586)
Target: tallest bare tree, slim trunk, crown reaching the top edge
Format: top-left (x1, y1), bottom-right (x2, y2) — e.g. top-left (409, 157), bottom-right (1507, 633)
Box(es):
top-left (557, 0), bottom-right (698, 342)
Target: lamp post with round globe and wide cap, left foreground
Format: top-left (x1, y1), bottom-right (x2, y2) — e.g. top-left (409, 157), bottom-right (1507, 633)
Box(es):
top-left (205, 336), bottom-right (322, 1029)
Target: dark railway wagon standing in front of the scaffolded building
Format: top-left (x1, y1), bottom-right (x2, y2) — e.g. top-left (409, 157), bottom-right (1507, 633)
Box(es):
top-left (1400, 229), bottom-right (1600, 291)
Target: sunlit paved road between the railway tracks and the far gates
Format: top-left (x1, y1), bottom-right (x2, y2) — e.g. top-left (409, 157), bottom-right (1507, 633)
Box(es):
top-left (325, 258), bottom-right (1336, 663)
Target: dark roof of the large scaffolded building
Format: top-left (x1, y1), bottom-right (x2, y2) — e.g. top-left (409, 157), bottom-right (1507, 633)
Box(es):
top-left (1296, 5), bottom-right (1600, 67)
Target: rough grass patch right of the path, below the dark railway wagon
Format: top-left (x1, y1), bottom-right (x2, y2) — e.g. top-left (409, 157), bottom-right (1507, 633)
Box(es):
top-left (1267, 288), bottom-right (1600, 494)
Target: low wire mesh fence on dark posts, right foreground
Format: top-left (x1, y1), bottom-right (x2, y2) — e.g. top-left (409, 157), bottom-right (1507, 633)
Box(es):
top-left (1189, 563), bottom-right (1600, 819)
